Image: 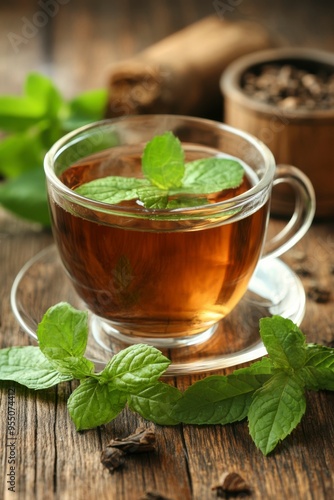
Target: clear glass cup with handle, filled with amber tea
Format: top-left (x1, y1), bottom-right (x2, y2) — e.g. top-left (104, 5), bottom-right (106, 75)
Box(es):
top-left (45, 115), bottom-right (315, 348)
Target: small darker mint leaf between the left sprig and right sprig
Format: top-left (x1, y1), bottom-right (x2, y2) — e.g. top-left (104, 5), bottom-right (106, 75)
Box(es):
top-left (128, 382), bottom-right (182, 425)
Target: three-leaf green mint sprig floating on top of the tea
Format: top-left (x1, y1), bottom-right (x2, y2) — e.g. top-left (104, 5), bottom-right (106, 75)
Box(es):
top-left (75, 131), bottom-right (245, 209)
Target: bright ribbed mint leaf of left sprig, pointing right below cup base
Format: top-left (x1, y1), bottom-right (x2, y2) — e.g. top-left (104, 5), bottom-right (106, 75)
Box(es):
top-left (99, 344), bottom-right (170, 394)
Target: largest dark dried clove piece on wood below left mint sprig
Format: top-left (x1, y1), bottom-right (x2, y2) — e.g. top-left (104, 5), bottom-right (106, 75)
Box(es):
top-left (101, 427), bottom-right (155, 473)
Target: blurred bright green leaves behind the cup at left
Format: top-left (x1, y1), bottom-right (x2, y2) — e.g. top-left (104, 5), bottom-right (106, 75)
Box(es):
top-left (0, 73), bottom-right (107, 226)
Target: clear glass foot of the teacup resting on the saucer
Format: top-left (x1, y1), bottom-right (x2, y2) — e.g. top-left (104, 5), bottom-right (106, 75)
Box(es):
top-left (90, 315), bottom-right (218, 352)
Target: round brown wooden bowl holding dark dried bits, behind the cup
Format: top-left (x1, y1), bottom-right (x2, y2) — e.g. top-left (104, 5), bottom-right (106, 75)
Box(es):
top-left (220, 48), bottom-right (334, 217)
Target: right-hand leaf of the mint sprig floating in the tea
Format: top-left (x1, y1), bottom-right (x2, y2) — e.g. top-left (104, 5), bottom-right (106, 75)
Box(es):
top-left (171, 158), bottom-right (245, 194)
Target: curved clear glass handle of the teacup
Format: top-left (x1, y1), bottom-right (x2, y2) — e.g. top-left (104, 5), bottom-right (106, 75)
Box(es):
top-left (262, 165), bottom-right (316, 259)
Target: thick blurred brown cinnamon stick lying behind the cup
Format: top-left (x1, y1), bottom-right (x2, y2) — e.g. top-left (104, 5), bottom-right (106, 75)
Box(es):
top-left (106, 16), bottom-right (274, 118)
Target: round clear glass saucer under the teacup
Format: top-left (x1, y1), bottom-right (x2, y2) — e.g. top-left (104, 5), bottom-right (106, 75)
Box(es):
top-left (11, 245), bottom-right (306, 375)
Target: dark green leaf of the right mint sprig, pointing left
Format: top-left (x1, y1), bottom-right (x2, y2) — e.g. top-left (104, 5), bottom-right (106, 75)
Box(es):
top-left (173, 369), bottom-right (271, 424)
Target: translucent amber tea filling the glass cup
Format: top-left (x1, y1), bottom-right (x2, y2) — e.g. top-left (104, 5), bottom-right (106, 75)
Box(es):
top-left (51, 146), bottom-right (268, 338)
